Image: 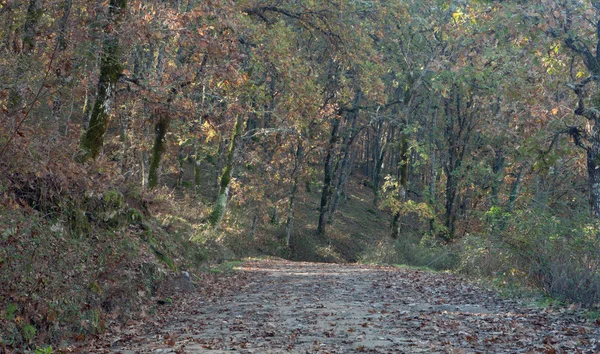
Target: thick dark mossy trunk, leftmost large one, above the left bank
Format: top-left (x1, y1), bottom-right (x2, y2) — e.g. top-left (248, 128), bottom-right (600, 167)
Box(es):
top-left (81, 0), bottom-right (127, 161)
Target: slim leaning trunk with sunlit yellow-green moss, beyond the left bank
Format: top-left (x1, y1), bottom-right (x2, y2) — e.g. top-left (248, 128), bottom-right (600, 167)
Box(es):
top-left (210, 114), bottom-right (244, 227)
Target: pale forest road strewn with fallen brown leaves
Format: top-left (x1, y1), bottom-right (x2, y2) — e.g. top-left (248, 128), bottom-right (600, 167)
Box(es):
top-left (83, 260), bottom-right (600, 354)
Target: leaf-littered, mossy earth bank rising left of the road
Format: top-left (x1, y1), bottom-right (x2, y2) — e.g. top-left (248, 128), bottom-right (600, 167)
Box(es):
top-left (0, 140), bottom-right (211, 352)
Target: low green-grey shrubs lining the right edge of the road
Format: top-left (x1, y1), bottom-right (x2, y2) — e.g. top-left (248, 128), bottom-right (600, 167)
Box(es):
top-left (460, 210), bottom-right (600, 307)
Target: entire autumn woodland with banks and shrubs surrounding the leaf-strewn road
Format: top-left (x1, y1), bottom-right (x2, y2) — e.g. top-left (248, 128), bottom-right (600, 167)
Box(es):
top-left (0, 0), bottom-right (600, 348)
